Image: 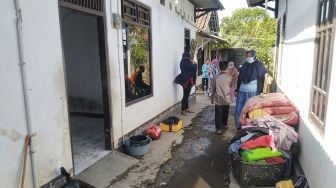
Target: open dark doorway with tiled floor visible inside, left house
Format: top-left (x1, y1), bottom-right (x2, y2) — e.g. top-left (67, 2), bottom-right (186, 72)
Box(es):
top-left (60, 4), bottom-right (112, 174)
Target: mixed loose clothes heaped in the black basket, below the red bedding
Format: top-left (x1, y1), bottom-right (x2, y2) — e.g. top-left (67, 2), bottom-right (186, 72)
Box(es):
top-left (229, 115), bottom-right (298, 164)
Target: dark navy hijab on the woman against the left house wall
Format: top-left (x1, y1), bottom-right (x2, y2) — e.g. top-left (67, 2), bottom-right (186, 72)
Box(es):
top-left (174, 52), bottom-right (197, 85)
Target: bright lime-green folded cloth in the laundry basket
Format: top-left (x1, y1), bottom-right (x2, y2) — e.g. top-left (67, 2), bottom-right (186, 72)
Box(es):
top-left (240, 148), bottom-right (281, 162)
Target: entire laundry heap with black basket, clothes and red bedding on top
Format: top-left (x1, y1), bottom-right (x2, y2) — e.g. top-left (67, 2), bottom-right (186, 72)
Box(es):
top-left (229, 93), bottom-right (299, 184)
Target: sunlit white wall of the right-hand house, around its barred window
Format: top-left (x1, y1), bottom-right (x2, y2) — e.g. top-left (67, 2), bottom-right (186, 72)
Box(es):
top-left (278, 0), bottom-right (336, 188)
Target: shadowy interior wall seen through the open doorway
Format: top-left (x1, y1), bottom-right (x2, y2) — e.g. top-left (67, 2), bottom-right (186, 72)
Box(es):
top-left (61, 8), bottom-right (103, 113)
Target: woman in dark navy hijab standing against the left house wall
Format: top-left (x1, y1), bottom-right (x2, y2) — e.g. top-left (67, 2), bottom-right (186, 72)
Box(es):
top-left (174, 52), bottom-right (197, 116)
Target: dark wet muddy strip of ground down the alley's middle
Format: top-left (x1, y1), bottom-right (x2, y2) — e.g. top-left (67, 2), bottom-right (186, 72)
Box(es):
top-left (152, 106), bottom-right (233, 188)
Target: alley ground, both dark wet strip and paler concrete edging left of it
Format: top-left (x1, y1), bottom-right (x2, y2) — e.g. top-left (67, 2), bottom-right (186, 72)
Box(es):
top-left (102, 95), bottom-right (234, 188)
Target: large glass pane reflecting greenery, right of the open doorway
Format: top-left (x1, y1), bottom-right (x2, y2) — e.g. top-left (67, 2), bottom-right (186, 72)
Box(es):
top-left (123, 24), bottom-right (152, 102)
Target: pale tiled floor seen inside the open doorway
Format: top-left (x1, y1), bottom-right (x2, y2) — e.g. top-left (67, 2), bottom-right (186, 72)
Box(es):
top-left (70, 115), bottom-right (110, 174)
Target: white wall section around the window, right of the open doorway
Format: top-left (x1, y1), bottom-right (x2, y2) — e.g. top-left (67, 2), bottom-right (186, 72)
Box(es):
top-left (107, 0), bottom-right (196, 144)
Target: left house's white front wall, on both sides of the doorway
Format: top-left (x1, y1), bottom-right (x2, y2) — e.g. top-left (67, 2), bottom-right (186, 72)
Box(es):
top-left (0, 0), bottom-right (196, 187)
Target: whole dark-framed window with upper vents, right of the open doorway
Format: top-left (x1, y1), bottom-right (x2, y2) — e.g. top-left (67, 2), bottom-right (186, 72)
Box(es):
top-left (122, 0), bottom-right (152, 104)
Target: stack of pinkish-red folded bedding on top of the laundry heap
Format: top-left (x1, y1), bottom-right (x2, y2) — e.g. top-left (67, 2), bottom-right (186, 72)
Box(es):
top-left (239, 93), bottom-right (299, 126)
